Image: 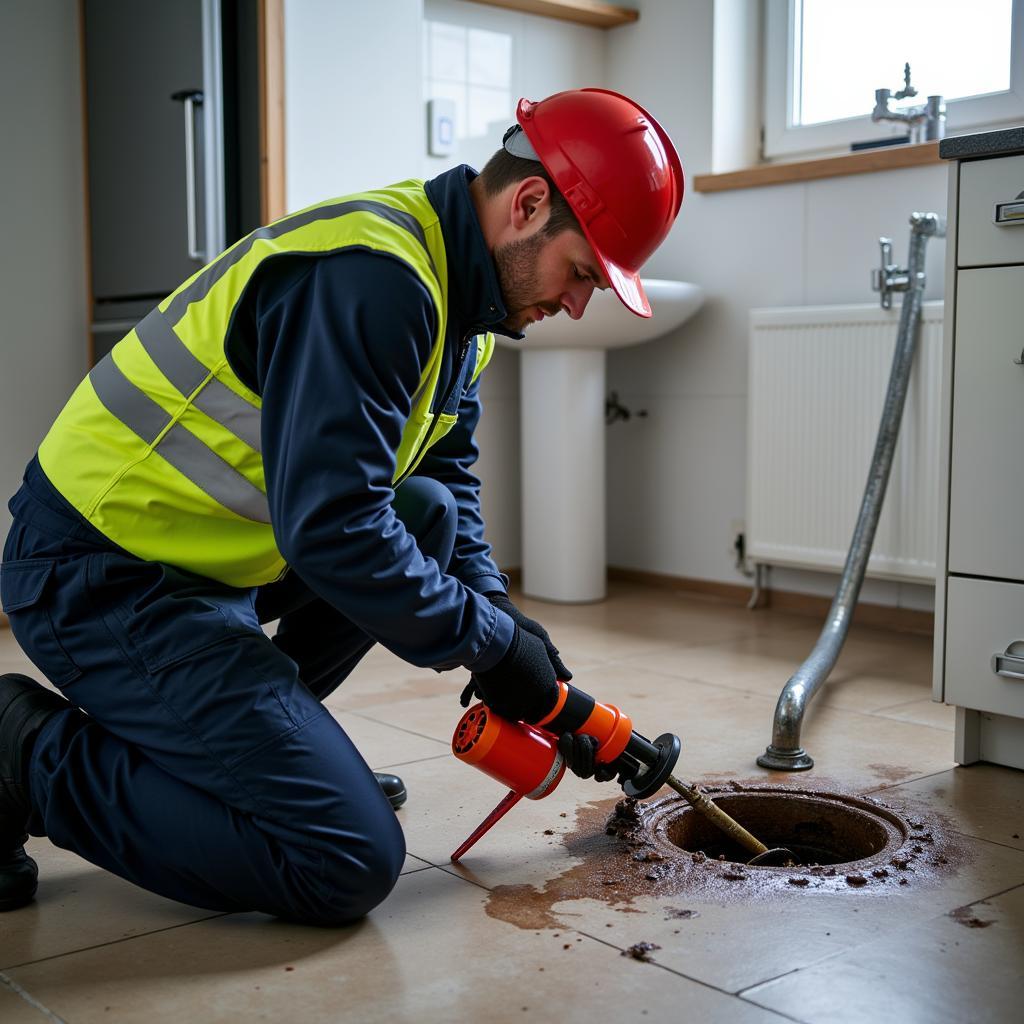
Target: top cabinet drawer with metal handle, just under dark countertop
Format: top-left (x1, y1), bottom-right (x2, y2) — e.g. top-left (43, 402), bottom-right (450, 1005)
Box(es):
top-left (956, 157), bottom-right (1024, 266)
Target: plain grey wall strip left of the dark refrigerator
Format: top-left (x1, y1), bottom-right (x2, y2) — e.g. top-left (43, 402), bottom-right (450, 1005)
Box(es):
top-left (0, 0), bottom-right (88, 537)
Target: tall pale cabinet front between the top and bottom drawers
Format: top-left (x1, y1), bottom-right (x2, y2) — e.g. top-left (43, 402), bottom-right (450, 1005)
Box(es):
top-left (949, 266), bottom-right (1024, 580)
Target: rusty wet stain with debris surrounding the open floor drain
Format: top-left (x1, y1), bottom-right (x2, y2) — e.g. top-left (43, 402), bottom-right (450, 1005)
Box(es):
top-left (485, 780), bottom-right (962, 931)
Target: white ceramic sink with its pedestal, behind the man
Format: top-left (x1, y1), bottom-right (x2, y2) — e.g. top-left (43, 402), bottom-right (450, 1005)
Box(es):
top-left (498, 280), bottom-right (705, 603)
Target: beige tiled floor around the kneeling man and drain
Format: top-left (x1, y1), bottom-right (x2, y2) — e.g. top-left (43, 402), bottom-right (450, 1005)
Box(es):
top-left (0, 585), bottom-right (1024, 1024)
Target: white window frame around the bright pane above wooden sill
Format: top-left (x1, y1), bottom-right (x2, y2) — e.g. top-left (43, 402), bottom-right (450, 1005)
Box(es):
top-left (762, 0), bottom-right (1024, 162)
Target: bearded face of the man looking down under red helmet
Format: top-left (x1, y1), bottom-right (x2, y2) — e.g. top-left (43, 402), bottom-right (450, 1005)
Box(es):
top-left (494, 222), bottom-right (608, 331)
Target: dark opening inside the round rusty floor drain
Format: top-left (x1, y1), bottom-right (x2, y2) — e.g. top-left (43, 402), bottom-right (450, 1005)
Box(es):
top-left (665, 794), bottom-right (905, 865)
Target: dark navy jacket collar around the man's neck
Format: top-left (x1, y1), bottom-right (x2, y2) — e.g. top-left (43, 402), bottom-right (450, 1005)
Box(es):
top-left (424, 164), bottom-right (524, 341)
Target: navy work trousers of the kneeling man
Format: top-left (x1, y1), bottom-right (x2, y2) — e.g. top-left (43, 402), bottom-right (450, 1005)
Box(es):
top-left (0, 460), bottom-right (458, 925)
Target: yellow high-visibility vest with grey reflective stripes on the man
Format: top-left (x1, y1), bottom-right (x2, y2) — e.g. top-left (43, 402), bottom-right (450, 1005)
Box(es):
top-left (39, 179), bottom-right (494, 587)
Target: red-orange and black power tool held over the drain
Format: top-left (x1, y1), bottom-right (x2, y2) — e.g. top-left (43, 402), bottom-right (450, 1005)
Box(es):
top-left (452, 682), bottom-right (680, 860)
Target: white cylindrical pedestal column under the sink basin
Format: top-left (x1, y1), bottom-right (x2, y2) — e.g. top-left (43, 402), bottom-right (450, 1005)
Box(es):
top-left (520, 348), bottom-right (607, 603)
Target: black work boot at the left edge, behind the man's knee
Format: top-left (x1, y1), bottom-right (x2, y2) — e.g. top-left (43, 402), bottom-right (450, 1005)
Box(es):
top-left (0, 674), bottom-right (71, 911)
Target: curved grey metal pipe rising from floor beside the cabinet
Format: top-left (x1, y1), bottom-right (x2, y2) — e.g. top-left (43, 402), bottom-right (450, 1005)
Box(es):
top-left (758, 213), bottom-right (946, 771)
